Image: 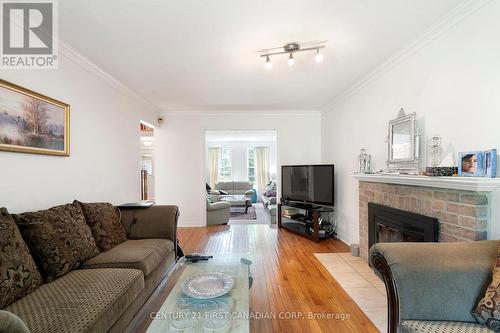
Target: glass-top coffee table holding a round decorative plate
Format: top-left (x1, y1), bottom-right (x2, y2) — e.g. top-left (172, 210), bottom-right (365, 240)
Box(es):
top-left (147, 255), bottom-right (269, 333)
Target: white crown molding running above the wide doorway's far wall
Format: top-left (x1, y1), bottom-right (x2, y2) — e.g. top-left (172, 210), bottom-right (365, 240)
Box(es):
top-left (160, 110), bottom-right (321, 117)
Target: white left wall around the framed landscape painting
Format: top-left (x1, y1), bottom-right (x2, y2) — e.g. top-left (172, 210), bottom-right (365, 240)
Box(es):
top-left (0, 48), bottom-right (157, 213)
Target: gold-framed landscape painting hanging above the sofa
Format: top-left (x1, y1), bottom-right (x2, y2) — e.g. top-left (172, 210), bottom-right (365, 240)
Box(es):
top-left (0, 80), bottom-right (69, 156)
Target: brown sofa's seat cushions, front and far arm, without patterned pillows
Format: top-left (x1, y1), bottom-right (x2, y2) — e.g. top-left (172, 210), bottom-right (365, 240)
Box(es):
top-left (0, 206), bottom-right (178, 333)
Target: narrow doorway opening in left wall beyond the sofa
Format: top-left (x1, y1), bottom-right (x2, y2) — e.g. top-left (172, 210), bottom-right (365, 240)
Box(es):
top-left (140, 121), bottom-right (154, 201)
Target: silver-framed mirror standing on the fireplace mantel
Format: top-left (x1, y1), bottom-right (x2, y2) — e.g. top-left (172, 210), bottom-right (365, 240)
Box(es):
top-left (386, 108), bottom-right (420, 174)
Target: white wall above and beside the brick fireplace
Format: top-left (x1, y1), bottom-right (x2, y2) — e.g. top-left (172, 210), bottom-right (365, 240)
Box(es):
top-left (322, 1), bottom-right (500, 242)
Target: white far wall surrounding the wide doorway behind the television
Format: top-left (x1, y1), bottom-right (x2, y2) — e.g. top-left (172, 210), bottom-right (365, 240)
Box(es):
top-left (155, 112), bottom-right (321, 226)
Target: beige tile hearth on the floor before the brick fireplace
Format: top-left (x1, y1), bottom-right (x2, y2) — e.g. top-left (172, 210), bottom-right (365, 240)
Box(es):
top-left (314, 253), bottom-right (387, 332)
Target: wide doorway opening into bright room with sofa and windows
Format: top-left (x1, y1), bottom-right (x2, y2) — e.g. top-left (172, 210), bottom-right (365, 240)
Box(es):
top-left (204, 130), bottom-right (278, 225)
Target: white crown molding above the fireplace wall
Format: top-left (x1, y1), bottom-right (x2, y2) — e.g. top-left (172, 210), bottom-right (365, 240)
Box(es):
top-left (321, 0), bottom-right (492, 113)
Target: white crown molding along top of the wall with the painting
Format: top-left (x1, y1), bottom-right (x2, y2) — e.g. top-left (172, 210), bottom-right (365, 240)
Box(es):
top-left (58, 39), bottom-right (160, 112)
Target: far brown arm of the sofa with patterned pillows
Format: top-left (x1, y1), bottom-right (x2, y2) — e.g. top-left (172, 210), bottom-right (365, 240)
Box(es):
top-left (120, 205), bottom-right (179, 243)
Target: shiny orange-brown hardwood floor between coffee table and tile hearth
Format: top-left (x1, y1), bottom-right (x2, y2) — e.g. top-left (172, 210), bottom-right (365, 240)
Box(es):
top-left (178, 225), bottom-right (378, 333)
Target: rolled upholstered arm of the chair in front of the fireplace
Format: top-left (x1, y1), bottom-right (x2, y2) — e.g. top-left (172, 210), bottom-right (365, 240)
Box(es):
top-left (370, 241), bottom-right (499, 333)
